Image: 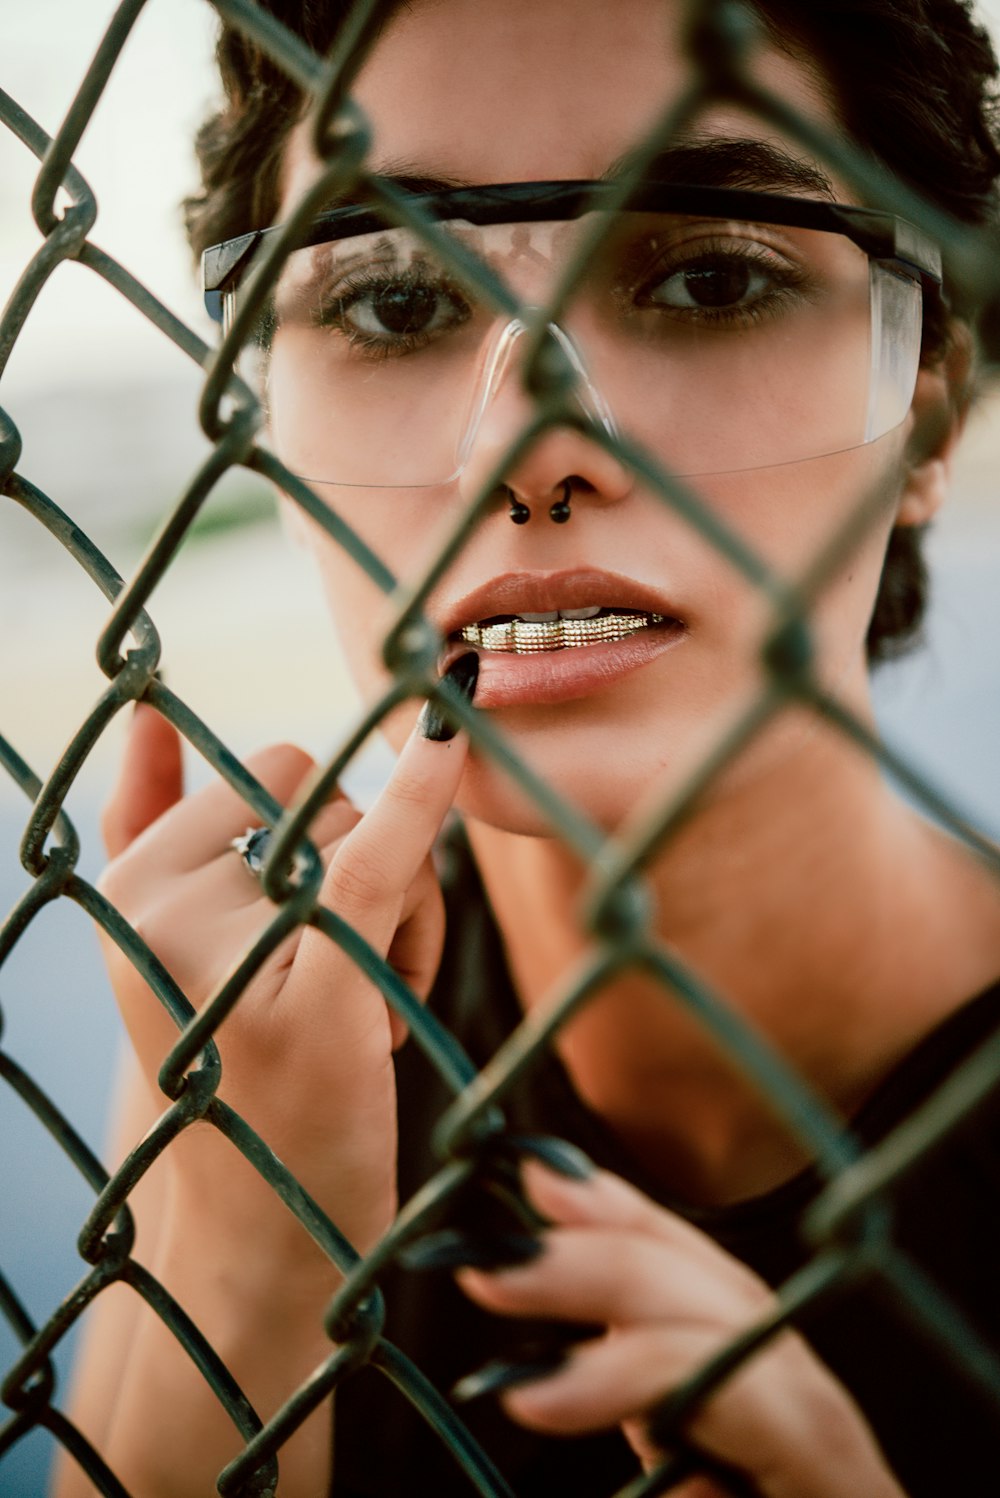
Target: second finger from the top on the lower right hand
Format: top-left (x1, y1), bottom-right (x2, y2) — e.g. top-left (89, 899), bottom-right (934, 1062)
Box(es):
top-left (458, 1228), bottom-right (771, 1327)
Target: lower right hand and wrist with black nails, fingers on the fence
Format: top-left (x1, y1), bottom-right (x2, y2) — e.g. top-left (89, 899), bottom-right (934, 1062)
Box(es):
top-left (458, 1159), bottom-right (903, 1498)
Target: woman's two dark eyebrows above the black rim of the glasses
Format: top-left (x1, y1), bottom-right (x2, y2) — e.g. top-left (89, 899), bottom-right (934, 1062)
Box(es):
top-left (350, 135), bottom-right (837, 207)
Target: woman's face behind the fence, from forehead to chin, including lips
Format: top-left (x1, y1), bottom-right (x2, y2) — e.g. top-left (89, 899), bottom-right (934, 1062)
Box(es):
top-left (274, 0), bottom-right (940, 831)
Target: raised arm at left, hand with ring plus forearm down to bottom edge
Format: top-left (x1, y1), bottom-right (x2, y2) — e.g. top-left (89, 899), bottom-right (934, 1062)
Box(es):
top-left (58, 680), bottom-right (475, 1498)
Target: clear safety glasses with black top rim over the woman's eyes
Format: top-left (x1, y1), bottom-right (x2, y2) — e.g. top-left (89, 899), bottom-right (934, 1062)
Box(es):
top-left (204, 183), bottom-right (940, 488)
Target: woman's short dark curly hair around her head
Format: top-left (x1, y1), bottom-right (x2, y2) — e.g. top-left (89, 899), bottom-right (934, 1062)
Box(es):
top-left (184, 0), bottom-right (1000, 664)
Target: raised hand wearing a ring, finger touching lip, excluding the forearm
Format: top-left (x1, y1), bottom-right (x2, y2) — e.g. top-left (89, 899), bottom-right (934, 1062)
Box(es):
top-left (102, 686), bottom-right (466, 1249)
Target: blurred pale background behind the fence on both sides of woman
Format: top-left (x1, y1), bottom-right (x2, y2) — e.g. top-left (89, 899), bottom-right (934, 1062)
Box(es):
top-left (0, 0), bottom-right (1000, 1498)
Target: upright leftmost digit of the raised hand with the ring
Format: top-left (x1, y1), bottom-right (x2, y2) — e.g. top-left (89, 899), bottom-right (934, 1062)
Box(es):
top-left (100, 703), bottom-right (184, 858)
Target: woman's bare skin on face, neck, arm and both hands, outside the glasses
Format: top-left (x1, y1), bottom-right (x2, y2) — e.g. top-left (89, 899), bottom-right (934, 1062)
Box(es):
top-left (60, 0), bottom-right (1000, 1498)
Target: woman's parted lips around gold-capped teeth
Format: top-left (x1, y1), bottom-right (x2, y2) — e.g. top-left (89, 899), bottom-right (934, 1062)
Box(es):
top-left (442, 568), bottom-right (687, 707)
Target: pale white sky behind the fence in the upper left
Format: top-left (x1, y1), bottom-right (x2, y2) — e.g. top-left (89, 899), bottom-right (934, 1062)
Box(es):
top-left (0, 0), bottom-right (1000, 389)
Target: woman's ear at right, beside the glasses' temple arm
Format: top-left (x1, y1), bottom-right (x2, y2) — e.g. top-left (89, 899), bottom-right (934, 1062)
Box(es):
top-left (895, 322), bottom-right (972, 526)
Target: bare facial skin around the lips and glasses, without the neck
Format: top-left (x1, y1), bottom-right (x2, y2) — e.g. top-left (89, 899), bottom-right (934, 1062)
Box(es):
top-left (286, 3), bottom-right (945, 831)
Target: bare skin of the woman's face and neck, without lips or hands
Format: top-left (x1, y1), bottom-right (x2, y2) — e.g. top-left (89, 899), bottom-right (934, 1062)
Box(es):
top-left (275, 0), bottom-right (1000, 1198)
